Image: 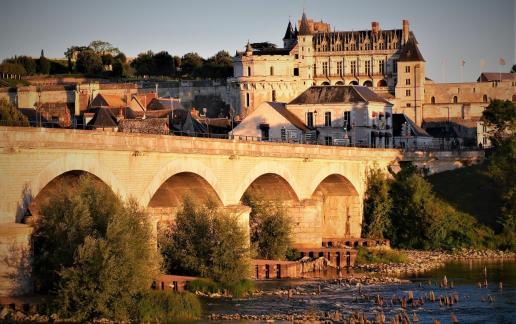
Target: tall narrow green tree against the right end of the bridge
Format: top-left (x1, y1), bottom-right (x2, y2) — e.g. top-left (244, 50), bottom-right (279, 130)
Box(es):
top-left (362, 168), bottom-right (392, 238)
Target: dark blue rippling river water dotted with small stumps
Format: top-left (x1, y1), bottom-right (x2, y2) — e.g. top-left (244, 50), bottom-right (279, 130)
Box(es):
top-left (203, 261), bottom-right (516, 324)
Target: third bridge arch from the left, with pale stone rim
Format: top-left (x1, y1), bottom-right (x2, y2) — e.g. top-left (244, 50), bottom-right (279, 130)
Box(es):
top-left (233, 162), bottom-right (301, 204)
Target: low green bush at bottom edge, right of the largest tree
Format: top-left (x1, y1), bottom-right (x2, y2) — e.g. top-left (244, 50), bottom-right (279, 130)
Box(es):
top-left (135, 291), bottom-right (201, 323)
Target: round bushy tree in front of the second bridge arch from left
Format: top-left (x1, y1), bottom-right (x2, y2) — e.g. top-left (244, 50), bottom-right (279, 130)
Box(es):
top-left (158, 198), bottom-right (249, 284)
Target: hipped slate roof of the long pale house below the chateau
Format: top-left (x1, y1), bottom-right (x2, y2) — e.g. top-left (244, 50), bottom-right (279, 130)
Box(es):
top-left (289, 86), bottom-right (390, 105)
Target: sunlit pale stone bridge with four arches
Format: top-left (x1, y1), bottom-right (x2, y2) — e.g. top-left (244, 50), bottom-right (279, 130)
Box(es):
top-left (0, 127), bottom-right (400, 294)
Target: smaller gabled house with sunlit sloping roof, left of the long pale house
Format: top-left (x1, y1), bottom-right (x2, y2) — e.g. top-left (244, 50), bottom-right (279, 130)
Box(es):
top-left (229, 102), bottom-right (315, 143)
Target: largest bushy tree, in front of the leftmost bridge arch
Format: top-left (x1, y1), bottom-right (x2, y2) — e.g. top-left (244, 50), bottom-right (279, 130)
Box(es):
top-left (32, 176), bottom-right (160, 321)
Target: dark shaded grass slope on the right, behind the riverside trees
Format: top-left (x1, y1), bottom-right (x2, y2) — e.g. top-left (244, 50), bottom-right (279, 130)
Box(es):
top-left (427, 164), bottom-right (502, 231)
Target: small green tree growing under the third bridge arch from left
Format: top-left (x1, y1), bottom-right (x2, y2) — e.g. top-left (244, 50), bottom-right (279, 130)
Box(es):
top-left (243, 195), bottom-right (292, 260)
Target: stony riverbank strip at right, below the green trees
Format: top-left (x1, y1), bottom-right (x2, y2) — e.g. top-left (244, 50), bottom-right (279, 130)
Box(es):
top-left (353, 249), bottom-right (516, 275)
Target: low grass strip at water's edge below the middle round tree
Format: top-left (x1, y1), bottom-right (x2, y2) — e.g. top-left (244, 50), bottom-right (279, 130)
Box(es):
top-left (186, 278), bottom-right (255, 298)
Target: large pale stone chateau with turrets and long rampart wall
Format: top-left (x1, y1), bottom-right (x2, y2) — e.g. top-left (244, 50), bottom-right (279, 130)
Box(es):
top-left (228, 13), bottom-right (516, 130)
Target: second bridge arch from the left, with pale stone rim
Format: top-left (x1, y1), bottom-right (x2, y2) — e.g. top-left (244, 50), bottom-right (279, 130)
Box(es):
top-left (140, 159), bottom-right (225, 207)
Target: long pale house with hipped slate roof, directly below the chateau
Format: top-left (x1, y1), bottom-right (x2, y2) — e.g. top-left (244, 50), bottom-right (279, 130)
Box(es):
top-left (286, 85), bottom-right (392, 147)
